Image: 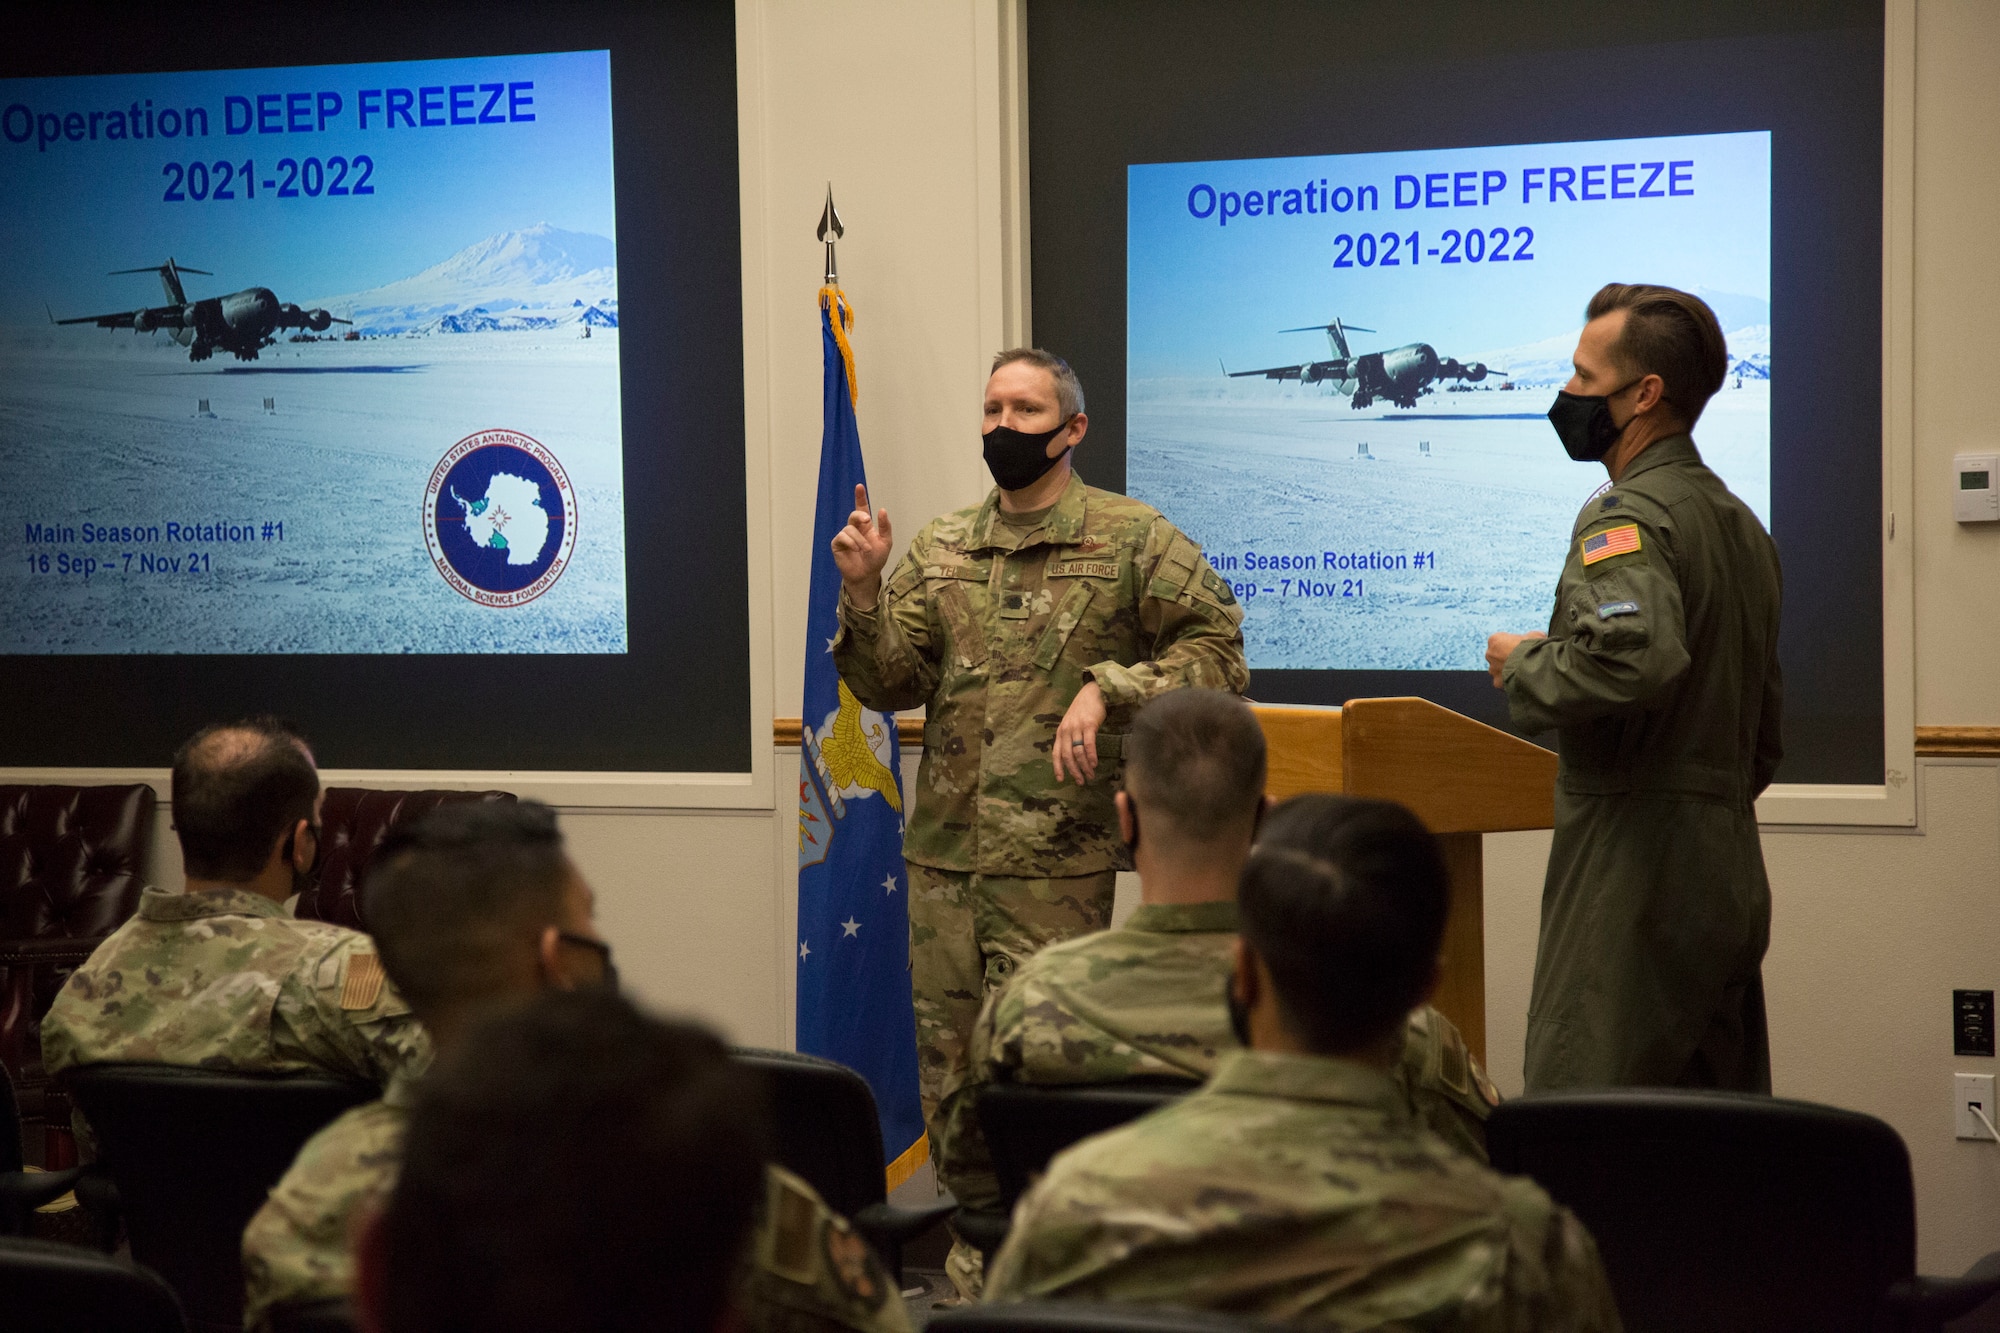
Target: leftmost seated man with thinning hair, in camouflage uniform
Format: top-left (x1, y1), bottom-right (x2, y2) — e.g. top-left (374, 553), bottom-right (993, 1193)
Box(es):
top-left (42, 719), bottom-right (430, 1085)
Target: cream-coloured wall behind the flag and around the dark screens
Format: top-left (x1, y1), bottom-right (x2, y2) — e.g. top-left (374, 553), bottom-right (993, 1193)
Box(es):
top-left (97, 0), bottom-right (2000, 1273)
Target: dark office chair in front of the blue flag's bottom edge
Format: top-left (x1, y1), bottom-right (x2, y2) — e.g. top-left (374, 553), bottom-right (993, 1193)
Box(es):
top-left (734, 1047), bottom-right (958, 1283)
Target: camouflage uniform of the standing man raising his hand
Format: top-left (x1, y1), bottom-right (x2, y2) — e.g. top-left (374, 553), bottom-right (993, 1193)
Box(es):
top-left (832, 476), bottom-right (1250, 1185)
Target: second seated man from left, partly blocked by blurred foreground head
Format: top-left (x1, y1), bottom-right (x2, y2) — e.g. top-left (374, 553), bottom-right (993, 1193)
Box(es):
top-left (244, 801), bottom-right (908, 1333)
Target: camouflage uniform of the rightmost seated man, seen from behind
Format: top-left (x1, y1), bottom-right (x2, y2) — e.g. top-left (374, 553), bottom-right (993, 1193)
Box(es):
top-left (986, 1051), bottom-right (1620, 1333)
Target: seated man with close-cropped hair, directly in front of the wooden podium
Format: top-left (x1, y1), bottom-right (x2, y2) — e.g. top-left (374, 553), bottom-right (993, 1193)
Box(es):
top-left (938, 691), bottom-right (1500, 1207)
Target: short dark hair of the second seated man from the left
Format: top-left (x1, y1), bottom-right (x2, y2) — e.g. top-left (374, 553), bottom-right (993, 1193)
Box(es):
top-left (362, 801), bottom-right (570, 1017)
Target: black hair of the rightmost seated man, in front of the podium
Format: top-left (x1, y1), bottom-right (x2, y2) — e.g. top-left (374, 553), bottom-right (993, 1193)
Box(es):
top-left (1238, 795), bottom-right (1452, 1055)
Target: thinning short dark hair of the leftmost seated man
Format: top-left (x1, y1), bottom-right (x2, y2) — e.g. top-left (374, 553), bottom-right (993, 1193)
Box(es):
top-left (174, 717), bottom-right (320, 885)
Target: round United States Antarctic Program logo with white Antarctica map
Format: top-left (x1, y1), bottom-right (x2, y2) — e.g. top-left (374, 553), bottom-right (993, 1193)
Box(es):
top-left (424, 430), bottom-right (576, 606)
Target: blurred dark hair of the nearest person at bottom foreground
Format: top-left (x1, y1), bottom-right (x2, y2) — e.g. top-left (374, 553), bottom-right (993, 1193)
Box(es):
top-left (382, 987), bottom-right (768, 1333)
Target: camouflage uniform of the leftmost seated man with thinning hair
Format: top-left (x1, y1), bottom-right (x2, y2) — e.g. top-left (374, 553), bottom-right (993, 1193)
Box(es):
top-left (42, 876), bottom-right (430, 1085)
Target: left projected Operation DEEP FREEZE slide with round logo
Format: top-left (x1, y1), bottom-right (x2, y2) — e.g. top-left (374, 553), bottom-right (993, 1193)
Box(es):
top-left (0, 49), bottom-right (626, 654)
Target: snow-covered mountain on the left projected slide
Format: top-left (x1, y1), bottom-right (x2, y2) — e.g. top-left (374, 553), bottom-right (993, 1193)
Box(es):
top-left (312, 222), bottom-right (618, 334)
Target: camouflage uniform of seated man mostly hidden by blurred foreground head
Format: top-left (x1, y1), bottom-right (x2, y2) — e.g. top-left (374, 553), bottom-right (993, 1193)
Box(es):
top-left (244, 1079), bottom-right (910, 1333)
